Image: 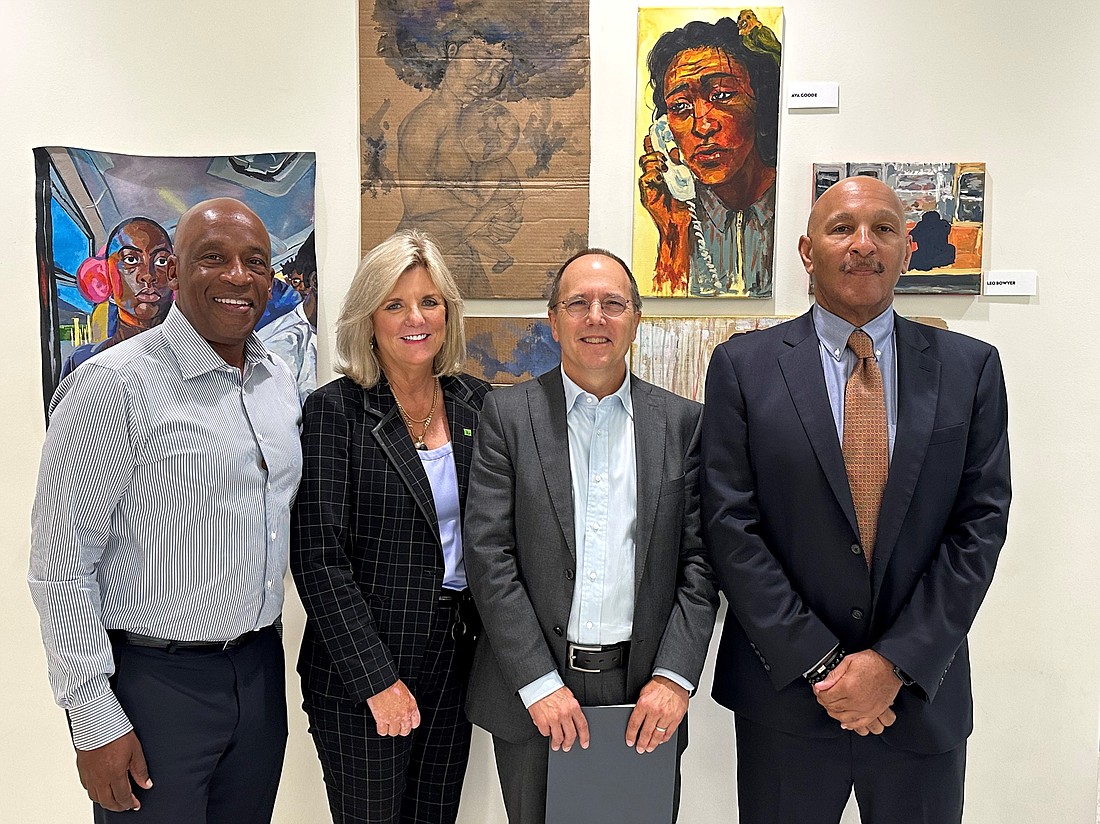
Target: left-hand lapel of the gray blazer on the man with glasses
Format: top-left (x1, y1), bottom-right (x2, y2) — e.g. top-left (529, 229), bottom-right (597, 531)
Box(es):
top-left (530, 366), bottom-right (576, 561)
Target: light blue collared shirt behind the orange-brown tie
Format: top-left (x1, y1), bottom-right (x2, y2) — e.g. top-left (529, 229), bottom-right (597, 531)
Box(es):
top-left (813, 304), bottom-right (898, 458)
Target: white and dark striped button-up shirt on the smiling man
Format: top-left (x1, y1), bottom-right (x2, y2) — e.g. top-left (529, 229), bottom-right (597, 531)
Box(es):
top-left (29, 306), bottom-right (301, 749)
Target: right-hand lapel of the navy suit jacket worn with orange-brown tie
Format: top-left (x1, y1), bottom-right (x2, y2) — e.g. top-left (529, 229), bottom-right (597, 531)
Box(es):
top-left (871, 316), bottom-right (939, 593)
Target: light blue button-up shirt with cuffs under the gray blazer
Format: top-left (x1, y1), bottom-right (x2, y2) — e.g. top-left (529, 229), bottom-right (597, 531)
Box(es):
top-left (519, 369), bottom-right (695, 707)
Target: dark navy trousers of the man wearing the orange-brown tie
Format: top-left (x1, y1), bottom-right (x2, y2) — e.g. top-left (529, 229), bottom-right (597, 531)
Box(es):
top-left (735, 715), bottom-right (966, 824)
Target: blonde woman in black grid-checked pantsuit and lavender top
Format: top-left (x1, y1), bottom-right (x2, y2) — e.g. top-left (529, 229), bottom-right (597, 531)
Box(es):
top-left (290, 230), bottom-right (490, 824)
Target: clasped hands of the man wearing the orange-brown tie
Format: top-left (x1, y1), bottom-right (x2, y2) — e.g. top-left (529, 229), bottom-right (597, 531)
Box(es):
top-left (814, 649), bottom-right (901, 732)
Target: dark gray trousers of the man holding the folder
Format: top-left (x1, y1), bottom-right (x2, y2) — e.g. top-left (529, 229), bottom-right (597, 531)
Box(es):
top-left (493, 669), bottom-right (686, 824)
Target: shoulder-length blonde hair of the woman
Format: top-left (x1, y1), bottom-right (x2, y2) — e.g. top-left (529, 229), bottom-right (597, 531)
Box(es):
top-left (336, 229), bottom-right (466, 388)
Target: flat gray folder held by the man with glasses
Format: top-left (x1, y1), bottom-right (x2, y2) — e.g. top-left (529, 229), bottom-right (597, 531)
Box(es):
top-left (546, 704), bottom-right (680, 824)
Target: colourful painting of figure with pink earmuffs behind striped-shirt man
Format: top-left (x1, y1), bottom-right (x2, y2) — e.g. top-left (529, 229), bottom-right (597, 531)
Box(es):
top-left (34, 146), bottom-right (317, 405)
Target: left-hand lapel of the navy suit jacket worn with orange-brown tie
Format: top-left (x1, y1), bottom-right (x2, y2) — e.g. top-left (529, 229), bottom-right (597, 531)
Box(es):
top-left (779, 312), bottom-right (859, 535)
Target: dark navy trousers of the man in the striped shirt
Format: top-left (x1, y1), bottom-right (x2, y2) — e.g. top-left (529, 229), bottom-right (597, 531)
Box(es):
top-left (95, 627), bottom-right (287, 824)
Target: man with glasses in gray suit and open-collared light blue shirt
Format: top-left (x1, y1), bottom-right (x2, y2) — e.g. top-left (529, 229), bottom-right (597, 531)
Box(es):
top-left (464, 249), bottom-right (717, 824)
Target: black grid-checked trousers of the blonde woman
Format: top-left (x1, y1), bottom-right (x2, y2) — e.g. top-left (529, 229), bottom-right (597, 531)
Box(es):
top-left (303, 602), bottom-right (475, 824)
